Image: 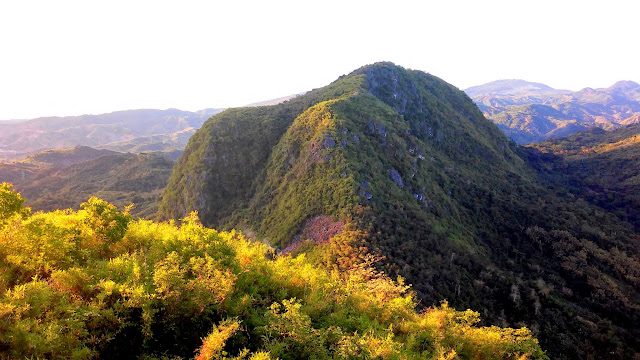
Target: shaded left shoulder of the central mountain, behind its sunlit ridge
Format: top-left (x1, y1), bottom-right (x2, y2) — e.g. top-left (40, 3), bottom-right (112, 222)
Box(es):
top-left (159, 73), bottom-right (363, 225)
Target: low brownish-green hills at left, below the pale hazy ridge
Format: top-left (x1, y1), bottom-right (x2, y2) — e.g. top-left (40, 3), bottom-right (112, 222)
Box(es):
top-left (0, 146), bottom-right (174, 217)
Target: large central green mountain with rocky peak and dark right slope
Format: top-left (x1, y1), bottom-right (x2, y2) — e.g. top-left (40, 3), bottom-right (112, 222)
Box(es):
top-left (159, 63), bottom-right (640, 359)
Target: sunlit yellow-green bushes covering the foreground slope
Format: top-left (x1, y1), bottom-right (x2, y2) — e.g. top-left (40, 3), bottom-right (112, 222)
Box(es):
top-left (0, 187), bottom-right (546, 360)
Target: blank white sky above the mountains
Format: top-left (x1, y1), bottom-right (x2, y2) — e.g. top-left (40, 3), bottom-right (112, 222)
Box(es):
top-left (0, 0), bottom-right (640, 119)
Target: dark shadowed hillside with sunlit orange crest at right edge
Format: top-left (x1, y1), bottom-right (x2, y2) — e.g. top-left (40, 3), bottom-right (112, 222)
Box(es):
top-left (528, 124), bottom-right (640, 232)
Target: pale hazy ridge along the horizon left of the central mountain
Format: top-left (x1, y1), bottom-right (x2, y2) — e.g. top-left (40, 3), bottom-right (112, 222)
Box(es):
top-left (0, 109), bottom-right (222, 159)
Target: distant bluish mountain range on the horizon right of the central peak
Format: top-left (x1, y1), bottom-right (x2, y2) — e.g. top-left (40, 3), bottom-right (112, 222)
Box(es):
top-left (465, 80), bottom-right (640, 144)
